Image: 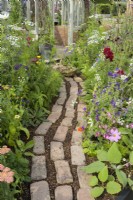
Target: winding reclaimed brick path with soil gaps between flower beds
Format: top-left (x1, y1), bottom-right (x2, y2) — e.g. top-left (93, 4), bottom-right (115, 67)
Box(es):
top-left (30, 77), bottom-right (93, 200)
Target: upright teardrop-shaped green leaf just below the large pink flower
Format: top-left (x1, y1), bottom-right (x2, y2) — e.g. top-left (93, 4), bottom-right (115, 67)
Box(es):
top-left (108, 142), bottom-right (122, 164)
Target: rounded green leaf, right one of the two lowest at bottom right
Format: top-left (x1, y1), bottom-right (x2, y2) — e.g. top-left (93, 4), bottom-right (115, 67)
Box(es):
top-left (106, 181), bottom-right (121, 194)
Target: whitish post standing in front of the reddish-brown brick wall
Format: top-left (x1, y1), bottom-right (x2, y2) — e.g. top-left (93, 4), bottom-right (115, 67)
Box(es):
top-left (68, 0), bottom-right (73, 45)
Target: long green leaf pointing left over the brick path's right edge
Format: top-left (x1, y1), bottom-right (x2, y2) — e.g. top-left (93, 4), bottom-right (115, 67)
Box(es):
top-left (83, 161), bottom-right (105, 174)
